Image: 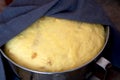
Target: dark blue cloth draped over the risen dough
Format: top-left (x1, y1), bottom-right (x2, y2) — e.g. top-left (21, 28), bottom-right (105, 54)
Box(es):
top-left (0, 0), bottom-right (120, 80)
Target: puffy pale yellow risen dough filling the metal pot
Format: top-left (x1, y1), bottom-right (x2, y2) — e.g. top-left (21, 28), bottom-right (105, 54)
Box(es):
top-left (4, 17), bottom-right (105, 72)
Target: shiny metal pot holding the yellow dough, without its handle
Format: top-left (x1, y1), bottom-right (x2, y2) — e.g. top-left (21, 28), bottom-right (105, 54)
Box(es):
top-left (0, 26), bottom-right (110, 80)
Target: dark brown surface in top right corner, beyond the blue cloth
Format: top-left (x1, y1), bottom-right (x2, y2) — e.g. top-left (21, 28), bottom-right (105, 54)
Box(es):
top-left (96, 0), bottom-right (120, 32)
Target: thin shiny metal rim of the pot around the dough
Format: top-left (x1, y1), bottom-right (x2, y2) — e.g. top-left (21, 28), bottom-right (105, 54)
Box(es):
top-left (0, 26), bottom-right (110, 74)
